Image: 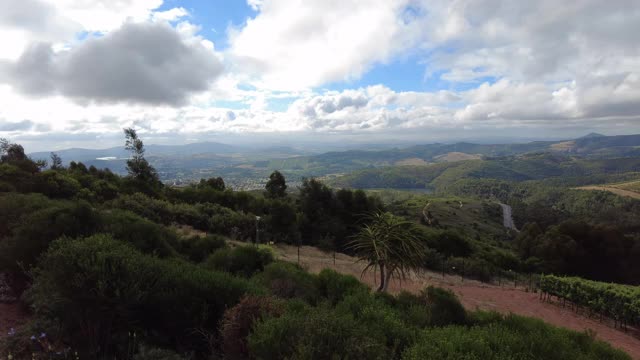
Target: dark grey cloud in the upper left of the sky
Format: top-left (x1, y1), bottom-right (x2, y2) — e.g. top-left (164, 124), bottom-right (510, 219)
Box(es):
top-left (0, 23), bottom-right (223, 106)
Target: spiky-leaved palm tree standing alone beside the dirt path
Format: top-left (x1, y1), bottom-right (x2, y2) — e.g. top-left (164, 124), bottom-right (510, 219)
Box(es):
top-left (349, 212), bottom-right (427, 291)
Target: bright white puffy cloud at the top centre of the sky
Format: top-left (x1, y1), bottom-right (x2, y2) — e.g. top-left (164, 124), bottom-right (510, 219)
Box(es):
top-left (229, 0), bottom-right (420, 90)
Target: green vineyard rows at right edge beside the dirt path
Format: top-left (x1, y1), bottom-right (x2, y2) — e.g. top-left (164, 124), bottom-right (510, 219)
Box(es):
top-left (540, 275), bottom-right (640, 328)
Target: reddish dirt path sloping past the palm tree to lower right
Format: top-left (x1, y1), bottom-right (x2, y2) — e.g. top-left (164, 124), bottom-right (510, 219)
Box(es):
top-left (275, 245), bottom-right (640, 360)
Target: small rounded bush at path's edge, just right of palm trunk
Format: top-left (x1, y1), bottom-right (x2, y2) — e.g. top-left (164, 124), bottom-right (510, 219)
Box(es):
top-left (421, 286), bottom-right (467, 326)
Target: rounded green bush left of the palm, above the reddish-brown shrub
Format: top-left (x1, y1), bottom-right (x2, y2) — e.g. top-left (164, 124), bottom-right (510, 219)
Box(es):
top-left (254, 261), bottom-right (318, 303)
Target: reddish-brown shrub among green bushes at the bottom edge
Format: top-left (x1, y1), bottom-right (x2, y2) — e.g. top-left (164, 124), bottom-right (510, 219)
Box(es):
top-left (221, 296), bottom-right (281, 360)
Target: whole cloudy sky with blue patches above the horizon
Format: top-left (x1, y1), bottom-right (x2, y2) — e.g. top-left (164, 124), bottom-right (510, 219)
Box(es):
top-left (0, 0), bottom-right (640, 151)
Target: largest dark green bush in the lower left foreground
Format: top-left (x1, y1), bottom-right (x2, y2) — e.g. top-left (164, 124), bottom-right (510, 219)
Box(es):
top-left (27, 235), bottom-right (259, 358)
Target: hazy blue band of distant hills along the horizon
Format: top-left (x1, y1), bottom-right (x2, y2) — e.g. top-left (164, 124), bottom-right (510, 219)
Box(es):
top-left (30, 133), bottom-right (640, 188)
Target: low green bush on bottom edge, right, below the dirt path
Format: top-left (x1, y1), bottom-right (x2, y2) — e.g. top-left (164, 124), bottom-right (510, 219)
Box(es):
top-left (403, 315), bottom-right (631, 360)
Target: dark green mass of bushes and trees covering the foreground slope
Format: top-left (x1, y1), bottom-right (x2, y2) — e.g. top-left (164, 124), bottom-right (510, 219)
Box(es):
top-left (0, 136), bottom-right (628, 360)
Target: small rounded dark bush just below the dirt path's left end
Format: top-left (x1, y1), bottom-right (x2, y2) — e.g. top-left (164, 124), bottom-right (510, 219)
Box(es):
top-left (205, 246), bottom-right (273, 277)
